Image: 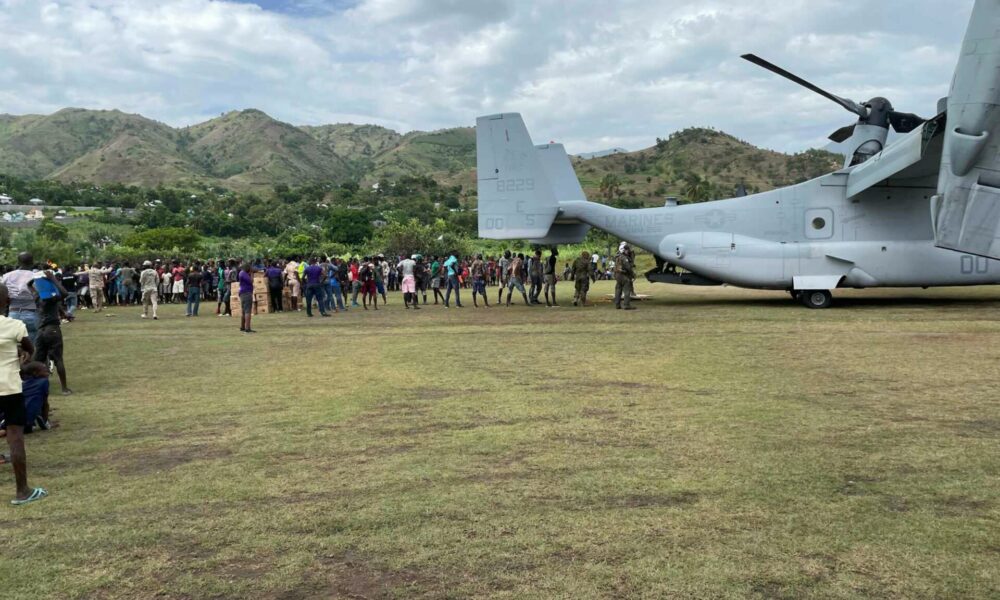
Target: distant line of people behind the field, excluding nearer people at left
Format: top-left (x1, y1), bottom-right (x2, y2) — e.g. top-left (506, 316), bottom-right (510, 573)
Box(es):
top-left (54, 244), bottom-right (634, 319)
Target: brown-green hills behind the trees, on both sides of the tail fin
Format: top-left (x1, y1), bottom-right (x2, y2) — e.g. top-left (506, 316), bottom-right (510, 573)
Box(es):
top-left (0, 109), bottom-right (840, 199)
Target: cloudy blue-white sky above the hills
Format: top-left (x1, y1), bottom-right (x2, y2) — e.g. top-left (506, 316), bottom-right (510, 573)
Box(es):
top-left (0, 0), bottom-right (973, 153)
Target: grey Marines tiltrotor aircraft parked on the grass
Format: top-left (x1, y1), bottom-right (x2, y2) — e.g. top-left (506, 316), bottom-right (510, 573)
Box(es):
top-left (476, 0), bottom-right (1000, 308)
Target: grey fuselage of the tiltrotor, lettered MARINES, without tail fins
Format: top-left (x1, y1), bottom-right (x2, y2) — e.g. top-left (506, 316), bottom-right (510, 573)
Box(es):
top-left (556, 170), bottom-right (1000, 290)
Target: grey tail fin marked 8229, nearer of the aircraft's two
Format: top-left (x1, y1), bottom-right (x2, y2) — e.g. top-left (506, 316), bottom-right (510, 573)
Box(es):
top-left (476, 113), bottom-right (564, 240)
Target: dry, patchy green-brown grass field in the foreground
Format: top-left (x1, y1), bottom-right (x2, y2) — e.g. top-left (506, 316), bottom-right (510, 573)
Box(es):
top-left (0, 284), bottom-right (1000, 600)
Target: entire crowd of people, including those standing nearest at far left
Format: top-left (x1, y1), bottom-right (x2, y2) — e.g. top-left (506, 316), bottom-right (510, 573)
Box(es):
top-left (0, 243), bottom-right (635, 505)
